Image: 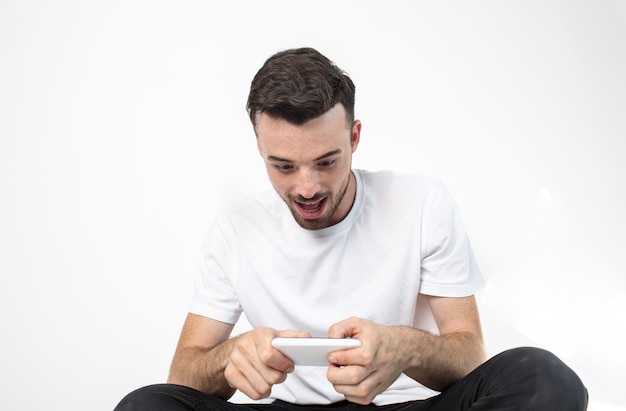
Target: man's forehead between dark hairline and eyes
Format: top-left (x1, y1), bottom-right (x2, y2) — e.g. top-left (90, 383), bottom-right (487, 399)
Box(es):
top-left (256, 104), bottom-right (350, 161)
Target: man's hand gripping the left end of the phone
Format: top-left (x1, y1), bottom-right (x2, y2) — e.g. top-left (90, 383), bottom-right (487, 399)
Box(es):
top-left (224, 328), bottom-right (311, 400)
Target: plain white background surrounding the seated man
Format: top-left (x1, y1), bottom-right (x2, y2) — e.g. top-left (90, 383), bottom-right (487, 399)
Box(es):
top-left (0, 0), bottom-right (626, 410)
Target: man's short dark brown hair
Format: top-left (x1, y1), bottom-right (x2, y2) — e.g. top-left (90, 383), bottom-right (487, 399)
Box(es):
top-left (247, 48), bottom-right (355, 127)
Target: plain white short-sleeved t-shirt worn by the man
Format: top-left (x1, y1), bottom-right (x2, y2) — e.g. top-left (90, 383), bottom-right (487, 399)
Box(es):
top-left (190, 170), bottom-right (483, 405)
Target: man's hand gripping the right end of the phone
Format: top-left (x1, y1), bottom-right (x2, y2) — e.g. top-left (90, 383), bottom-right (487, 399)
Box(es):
top-left (326, 317), bottom-right (408, 405)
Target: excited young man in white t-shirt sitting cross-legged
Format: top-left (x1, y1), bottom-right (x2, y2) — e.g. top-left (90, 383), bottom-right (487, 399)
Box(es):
top-left (117, 48), bottom-right (587, 411)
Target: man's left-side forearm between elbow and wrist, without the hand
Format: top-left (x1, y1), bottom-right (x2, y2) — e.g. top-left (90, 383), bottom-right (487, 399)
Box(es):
top-left (167, 340), bottom-right (235, 399)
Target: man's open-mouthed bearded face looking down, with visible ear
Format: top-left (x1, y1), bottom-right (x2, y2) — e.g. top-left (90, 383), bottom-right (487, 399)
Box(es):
top-left (256, 104), bottom-right (361, 230)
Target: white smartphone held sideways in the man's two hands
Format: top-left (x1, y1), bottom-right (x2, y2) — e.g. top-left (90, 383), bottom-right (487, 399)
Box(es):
top-left (272, 337), bottom-right (361, 366)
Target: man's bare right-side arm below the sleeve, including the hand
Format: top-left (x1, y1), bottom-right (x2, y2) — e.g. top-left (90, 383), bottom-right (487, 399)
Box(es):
top-left (327, 295), bottom-right (486, 404)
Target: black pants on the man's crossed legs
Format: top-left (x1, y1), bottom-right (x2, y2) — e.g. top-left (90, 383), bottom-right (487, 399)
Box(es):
top-left (115, 348), bottom-right (587, 411)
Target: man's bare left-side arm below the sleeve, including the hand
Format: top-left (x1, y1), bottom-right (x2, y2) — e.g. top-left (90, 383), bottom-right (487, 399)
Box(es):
top-left (167, 314), bottom-right (309, 399)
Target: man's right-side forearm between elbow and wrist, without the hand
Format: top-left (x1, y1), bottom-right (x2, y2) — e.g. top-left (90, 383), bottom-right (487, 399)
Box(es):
top-left (397, 327), bottom-right (486, 391)
